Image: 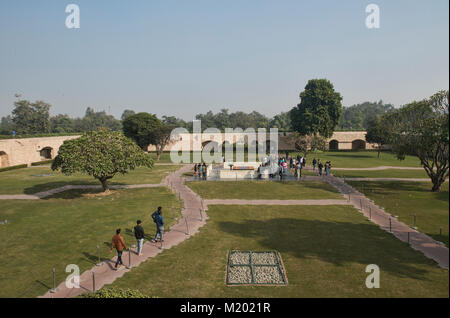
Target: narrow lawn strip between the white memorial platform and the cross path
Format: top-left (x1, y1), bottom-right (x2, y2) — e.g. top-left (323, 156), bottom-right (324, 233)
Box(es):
top-left (186, 181), bottom-right (343, 200)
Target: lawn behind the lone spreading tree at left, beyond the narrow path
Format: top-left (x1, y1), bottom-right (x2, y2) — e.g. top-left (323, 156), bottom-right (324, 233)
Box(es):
top-left (0, 165), bottom-right (181, 194)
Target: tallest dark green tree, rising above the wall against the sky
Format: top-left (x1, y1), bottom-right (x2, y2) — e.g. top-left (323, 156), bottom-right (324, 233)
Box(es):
top-left (290, 79), bottom-right (342, 138)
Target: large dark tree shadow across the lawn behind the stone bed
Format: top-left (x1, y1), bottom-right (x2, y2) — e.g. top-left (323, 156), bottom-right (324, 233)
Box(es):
top-left (218, 218), bottom-right (440, 280)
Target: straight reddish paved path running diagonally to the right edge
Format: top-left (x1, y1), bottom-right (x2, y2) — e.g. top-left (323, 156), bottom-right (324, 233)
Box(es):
top-left (323, 176), bottom-right (449, 269)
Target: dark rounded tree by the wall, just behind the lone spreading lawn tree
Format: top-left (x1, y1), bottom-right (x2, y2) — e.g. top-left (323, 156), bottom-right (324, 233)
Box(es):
top-left (122, 113), bottom-right (162, 150)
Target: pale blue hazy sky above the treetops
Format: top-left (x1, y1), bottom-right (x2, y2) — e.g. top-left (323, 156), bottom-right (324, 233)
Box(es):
top-left (0, 0), bottom-right (449, 120)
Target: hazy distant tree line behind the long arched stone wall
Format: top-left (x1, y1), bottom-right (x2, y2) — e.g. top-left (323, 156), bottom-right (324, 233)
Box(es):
top-left (0, 96), bottom-right (394, 135)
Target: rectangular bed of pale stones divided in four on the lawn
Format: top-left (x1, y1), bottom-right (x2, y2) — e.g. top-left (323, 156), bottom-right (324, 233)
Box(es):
top-left (226, 251), bottom-right (287, 286)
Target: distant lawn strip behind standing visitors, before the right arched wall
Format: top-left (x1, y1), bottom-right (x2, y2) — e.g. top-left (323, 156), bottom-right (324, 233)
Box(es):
top-left (288, 151), bottom-right (420, 168)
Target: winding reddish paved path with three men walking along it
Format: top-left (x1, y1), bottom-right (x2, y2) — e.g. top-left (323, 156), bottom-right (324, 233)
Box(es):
top-left (41, 166), bottom-right (208, 298)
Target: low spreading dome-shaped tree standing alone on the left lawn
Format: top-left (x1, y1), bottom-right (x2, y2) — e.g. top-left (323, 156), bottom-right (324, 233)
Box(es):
top-left (52, 129), bottom-right (153, 191)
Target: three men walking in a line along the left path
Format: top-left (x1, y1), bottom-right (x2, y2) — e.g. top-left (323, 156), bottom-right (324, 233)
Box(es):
top-left (110, 207), bottom-right (164, 270)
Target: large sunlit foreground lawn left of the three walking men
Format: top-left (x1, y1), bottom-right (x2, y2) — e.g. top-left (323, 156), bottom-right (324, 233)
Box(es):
top-left (0, 187), bottom-right (181, 297)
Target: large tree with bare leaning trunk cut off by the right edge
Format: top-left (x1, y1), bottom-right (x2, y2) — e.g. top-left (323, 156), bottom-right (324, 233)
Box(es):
top-left (385, 91), bottom-right (449, 192)
